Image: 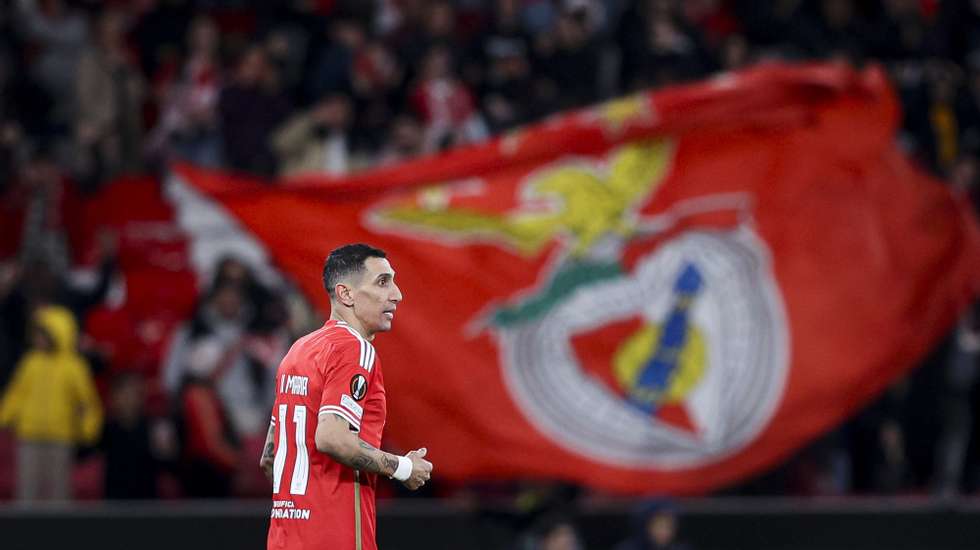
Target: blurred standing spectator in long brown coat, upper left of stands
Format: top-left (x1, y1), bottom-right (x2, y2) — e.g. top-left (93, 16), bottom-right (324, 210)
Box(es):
top-left (75, 10), bottom-right (144, 189)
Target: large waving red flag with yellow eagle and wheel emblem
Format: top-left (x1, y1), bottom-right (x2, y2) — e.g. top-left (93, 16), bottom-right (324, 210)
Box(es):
top-left (179, 65), bottom-right (980, 493)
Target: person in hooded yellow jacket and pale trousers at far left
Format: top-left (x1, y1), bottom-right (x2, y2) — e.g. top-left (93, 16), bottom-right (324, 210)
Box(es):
top-left (0, 306), bottom-right (102, 500)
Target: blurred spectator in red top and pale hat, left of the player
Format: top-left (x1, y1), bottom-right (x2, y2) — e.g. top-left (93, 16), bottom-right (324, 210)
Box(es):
top-left (180, 338), bottom-right (239, 498)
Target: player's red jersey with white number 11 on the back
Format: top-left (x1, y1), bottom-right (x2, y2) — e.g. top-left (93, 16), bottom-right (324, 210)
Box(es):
top-left (268, 320), bottom-right (386, 550)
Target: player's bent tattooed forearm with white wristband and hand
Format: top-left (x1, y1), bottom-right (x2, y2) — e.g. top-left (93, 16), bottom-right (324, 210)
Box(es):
top-left (314, 412), bottom-right (432, 490)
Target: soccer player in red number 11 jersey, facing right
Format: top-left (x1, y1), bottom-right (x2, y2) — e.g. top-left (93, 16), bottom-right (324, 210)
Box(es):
top-left (259, 244), bottom-right (432, 550)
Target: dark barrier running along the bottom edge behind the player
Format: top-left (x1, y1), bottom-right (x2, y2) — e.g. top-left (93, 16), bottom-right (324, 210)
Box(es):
top-left (0, 498), bottom-right (980, 550)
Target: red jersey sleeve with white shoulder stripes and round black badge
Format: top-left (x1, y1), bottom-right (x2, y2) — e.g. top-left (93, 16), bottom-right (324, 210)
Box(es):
top-left (319, 338), bottom-right (374, 431)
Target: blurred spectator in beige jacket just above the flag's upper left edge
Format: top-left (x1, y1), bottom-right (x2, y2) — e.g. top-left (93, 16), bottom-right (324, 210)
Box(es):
top-left (272, 94), bottom-right (365, 176)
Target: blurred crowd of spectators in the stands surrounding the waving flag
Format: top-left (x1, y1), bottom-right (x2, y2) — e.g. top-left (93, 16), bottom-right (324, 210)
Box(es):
top-left (0, 0), bottom-right (980, 549)
